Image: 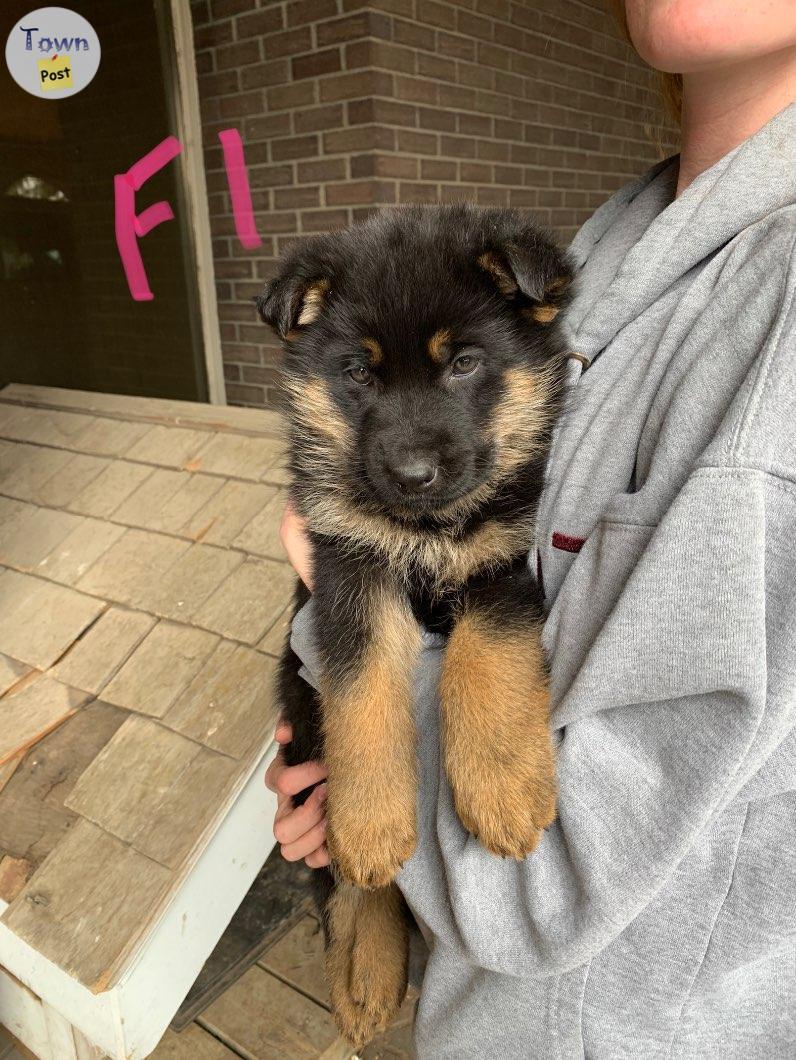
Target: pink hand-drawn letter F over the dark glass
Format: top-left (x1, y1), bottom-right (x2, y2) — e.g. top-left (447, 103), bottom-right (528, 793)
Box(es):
top-left (113, 136), bottom-right (182, 302)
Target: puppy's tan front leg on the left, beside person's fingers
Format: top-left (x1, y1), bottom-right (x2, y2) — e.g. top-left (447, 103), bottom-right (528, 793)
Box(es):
top-left (316, 546), bottom-right (421, 888)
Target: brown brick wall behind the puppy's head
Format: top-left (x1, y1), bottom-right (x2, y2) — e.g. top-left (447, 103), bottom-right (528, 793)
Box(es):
top-left (192, 0), bottom-right (674, 405)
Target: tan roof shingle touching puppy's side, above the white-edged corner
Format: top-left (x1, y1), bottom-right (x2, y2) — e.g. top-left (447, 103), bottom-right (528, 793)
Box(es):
top-left (163, 640), bottom-right (278, 758)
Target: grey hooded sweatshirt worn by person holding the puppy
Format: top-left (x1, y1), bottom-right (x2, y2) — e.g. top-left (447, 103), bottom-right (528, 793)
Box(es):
top-left (294, 105), bottom-right (796, 1060)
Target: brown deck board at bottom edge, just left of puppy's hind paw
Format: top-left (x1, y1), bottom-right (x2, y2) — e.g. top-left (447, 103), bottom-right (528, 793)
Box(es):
top-left (198, 966), bottom-right (351, 1060)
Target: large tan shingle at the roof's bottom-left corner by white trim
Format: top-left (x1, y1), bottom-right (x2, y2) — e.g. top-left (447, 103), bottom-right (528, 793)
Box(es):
top-left (2, 818), bottom-right (172, 993)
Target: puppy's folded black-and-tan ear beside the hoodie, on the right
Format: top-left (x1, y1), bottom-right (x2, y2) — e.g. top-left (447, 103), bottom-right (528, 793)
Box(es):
top-left (478, 234), bottom-right (572, 323)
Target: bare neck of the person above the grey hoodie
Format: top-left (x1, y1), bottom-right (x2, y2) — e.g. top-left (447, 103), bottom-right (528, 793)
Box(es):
top-left (677, 48), bottom-right (796, 195)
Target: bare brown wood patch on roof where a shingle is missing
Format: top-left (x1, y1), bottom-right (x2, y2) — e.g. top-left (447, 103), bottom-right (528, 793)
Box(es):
top-left (0, 702), bottom-right (126, 865)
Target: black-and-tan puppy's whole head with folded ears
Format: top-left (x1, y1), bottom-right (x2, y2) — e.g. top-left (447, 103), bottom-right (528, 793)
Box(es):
top-left (259, 207), bottom-right (569, 518)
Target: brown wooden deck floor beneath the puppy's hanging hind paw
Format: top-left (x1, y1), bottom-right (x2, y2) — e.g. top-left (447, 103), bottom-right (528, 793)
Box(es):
top-left (152, 916), bottom-right (418, 1060)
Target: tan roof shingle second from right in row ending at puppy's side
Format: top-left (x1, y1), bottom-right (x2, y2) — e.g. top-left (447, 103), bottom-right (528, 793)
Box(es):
top-left (103, 622), bottom-right (218, 718)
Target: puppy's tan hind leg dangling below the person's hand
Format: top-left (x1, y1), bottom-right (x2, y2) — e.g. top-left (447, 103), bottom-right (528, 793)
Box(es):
top-left (319, 873), bottom-right (409, 1048)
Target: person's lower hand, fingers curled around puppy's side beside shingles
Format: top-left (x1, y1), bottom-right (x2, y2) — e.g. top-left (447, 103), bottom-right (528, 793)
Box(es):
top-left (265, 722), bottom-right (331, 868)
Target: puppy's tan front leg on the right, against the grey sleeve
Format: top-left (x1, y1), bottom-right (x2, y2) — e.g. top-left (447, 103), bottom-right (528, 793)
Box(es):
top-left (440, 564), bottom-right (555, 859)
